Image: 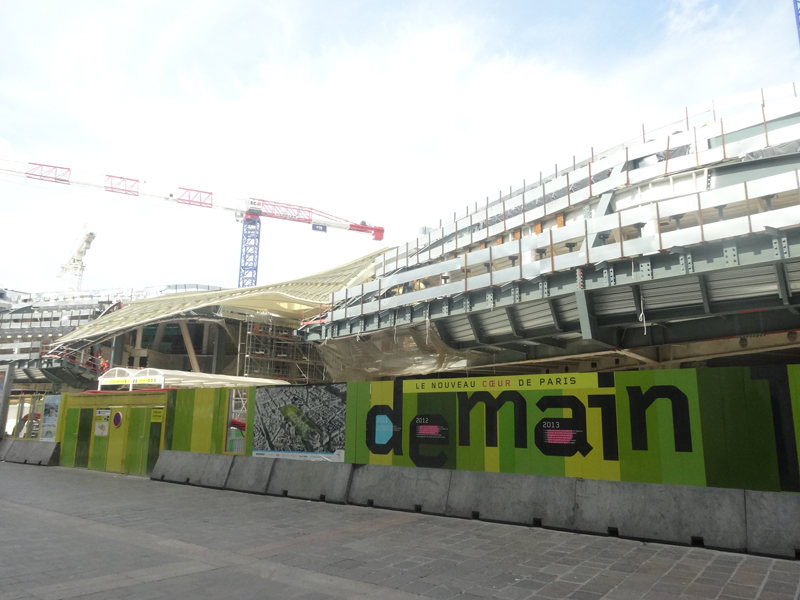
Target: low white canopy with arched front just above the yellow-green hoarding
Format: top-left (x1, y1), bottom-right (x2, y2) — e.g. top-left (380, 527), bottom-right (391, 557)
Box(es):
top-left (97, 367), bottom-right (288, 390)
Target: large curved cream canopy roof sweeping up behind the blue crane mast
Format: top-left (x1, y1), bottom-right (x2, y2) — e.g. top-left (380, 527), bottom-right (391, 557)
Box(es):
top-left (58, 249), bottom-right (385, 344)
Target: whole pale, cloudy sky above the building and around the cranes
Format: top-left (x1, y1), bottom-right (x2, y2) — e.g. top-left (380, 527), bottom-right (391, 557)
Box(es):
top-left (0, 0), bottom-right (800, 292)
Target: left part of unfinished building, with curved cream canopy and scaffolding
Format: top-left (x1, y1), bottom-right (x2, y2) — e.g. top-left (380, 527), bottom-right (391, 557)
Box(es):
top-left (0, 248), bottom-right (384, 392)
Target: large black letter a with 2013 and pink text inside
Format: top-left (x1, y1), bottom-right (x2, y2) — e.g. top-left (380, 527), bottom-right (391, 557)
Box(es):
top-left (534, 396), bottom-right (592, 456)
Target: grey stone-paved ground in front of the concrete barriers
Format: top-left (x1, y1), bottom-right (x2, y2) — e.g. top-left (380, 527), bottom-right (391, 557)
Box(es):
top-left (0, 463), bottom-right (800, 600)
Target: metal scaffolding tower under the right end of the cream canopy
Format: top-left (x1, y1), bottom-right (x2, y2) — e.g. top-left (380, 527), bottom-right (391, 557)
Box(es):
top-left (243, 317), bottom-right (330, 384)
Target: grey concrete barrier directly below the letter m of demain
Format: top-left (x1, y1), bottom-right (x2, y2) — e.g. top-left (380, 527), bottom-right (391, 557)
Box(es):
top-left (445, 471), bottom-right (576, 530)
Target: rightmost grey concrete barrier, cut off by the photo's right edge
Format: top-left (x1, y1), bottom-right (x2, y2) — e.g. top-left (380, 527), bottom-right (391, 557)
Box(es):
top-left (745, 490), bottom-right (800, 558)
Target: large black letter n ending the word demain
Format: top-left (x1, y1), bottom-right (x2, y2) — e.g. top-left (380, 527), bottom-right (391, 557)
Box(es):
top-left (628, 385), bottom-right (692, 452)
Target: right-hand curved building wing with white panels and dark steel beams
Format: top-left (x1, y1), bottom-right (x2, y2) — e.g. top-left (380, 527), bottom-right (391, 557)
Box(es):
top-left (301, 84), bottom-right (800, 376)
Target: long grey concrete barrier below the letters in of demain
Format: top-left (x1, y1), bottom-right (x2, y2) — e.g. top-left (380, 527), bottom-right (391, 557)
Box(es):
top-left (575, 479), bottom-right (747, 551)
